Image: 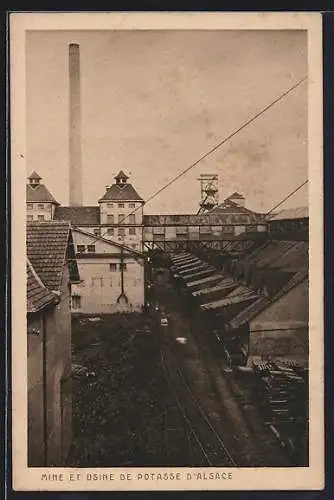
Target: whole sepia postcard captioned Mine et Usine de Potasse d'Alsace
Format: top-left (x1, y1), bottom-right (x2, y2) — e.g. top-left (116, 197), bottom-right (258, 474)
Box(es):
top-left (10, 12), bottom-right (324, 491)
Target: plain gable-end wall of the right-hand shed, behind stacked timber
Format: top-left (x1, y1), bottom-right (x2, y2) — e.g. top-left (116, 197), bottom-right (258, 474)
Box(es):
top-left (249, 280), bottom-right (308, 361)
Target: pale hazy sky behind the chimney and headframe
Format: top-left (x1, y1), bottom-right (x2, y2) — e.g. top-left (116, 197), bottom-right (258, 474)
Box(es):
top-left (26, 30), bottom-right (308, 213)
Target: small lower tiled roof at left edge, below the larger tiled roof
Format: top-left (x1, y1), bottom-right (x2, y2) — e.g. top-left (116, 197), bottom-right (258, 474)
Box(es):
top-left (27, 259), bottom-right (57, 313)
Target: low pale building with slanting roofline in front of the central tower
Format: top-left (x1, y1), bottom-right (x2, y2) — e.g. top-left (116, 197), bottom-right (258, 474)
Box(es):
top-left (72, 227), bottom-right (145, 314)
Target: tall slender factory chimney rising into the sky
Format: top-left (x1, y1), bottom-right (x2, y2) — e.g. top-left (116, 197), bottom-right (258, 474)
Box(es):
top-left (69, 43), bottom-right (83, 207)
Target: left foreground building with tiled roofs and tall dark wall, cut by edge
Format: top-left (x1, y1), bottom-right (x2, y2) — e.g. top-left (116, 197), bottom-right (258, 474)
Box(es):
top-left (26, 220), bottom-right (79, 467)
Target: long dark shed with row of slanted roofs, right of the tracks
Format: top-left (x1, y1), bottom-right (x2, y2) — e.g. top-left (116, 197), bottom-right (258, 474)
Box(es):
top-left (172, 207), bottom-right (309, 365)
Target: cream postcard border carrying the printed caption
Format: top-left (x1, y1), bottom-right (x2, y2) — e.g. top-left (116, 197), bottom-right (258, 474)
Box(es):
top-left (10, 13), bottom-right (324, 491)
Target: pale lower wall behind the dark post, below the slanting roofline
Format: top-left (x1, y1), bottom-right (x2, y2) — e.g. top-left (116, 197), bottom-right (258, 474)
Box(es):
top-left (72, 253), bottom-right (144, 314)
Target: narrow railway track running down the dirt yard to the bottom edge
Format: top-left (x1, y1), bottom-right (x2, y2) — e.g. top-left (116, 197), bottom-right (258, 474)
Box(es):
top-left (161, 343), bottom-right (236, 467)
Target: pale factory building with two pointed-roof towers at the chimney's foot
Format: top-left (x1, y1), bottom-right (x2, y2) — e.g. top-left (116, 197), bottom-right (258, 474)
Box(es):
top-left (27, 171), bottom-right (145, 314)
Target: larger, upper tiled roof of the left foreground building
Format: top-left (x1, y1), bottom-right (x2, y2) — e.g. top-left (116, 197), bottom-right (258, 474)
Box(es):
top-left (27, 221), bottom-right (70, 291)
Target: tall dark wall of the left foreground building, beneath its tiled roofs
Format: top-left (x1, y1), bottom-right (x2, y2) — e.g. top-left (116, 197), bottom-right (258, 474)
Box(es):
top-left (27, 267), bottom-right (72, 467)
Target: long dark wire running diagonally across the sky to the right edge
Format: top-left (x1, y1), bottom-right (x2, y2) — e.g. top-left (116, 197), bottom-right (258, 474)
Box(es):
top-left (85, 76), bottom-right (307, 245)
